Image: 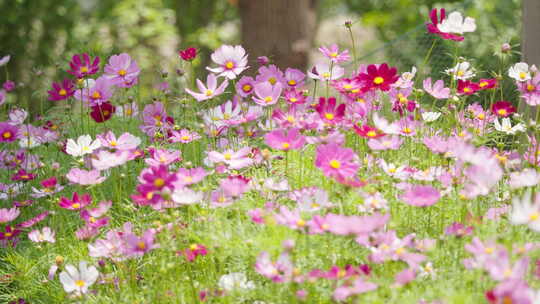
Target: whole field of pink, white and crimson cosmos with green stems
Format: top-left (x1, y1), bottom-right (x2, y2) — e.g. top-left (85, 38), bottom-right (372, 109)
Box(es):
top-left (0, 9), bottom-right (540, 304)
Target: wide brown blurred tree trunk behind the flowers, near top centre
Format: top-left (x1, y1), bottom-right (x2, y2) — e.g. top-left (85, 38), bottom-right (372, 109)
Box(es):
top-left (239, 0), bottom-right (317, 70)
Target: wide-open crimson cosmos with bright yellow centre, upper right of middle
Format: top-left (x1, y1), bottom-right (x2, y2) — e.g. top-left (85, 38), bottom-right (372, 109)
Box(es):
top-left (356, 63), bottom-right (399, 91)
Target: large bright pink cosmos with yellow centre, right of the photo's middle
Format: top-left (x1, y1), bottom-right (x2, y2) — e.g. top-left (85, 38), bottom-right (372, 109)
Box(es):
top-left (315, 143), bottom-right (360, 178)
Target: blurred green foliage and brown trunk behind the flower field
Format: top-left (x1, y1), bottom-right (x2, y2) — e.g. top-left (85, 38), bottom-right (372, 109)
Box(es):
top-left (0, 0), bottom-right (524, 113)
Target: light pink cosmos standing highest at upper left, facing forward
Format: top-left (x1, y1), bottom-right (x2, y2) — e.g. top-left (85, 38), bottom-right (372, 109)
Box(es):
top-left (103, 53), bottom-right (141, 88)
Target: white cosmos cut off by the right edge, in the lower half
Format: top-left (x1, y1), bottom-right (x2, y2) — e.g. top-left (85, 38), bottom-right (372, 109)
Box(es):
top-left (510, 190), bottom-right (540, 232)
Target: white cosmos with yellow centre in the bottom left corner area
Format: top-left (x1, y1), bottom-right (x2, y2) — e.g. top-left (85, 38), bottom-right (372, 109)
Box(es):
top-left (60, 261), bottom-right (99, 293)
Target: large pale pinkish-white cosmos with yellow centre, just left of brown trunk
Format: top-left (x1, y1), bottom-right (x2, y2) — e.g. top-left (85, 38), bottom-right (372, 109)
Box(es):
top-left (207, 45), bottom-right (248, 79)
